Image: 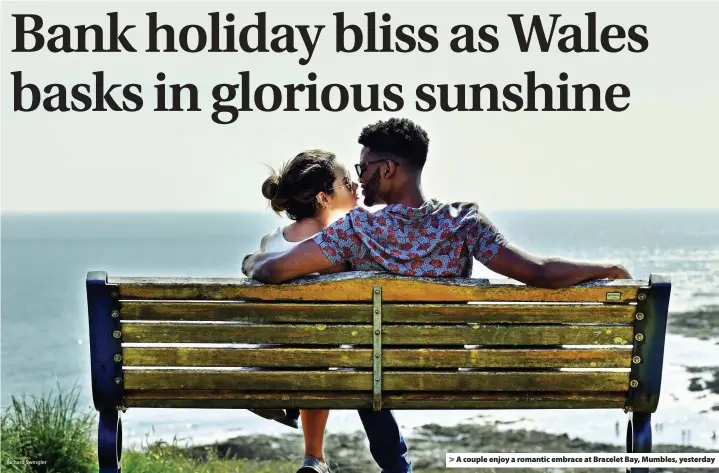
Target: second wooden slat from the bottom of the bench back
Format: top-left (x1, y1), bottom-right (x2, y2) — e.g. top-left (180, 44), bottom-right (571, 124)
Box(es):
top-left (123, 369), bottom-right (629, 392)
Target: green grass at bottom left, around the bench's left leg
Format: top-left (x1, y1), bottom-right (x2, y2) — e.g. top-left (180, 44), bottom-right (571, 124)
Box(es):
top-left (0, 387), bottom-right (316, 473)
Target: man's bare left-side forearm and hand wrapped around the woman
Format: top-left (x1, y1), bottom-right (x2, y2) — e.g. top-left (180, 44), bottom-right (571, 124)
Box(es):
top-left (242, 240), bottom-right (346, 284)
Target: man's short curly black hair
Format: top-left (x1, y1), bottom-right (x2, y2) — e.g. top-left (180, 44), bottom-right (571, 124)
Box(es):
top-left (357, 118), bottom-right (429, 169)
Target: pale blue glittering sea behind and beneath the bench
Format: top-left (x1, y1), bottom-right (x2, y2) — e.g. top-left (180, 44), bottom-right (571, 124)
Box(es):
top-left (0, 209), bottom-right (719, 449)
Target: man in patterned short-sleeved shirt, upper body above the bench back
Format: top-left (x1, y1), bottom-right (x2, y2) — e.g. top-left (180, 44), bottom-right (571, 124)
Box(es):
top-left (242, 118), bottom-right (631, 288)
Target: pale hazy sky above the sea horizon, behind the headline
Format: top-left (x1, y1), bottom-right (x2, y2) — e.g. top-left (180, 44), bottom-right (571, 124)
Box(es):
top-left (2, 1), bottom-right (719, 212)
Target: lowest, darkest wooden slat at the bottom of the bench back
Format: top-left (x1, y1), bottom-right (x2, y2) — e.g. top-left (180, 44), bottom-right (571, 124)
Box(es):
top-left (125, 390), bottom-right (626, 409)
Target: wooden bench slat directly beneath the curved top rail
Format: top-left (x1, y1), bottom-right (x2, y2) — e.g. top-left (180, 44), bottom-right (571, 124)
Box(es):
top-left (120, 301), bottom-right (636, 323)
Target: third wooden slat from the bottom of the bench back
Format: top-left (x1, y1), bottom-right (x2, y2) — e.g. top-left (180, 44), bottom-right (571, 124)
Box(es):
top-left (123, 347), bottom-right (632, 369)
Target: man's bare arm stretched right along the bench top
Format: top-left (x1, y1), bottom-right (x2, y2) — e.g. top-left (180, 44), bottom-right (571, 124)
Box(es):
top-left (486, 243), bottom-right (632, 289)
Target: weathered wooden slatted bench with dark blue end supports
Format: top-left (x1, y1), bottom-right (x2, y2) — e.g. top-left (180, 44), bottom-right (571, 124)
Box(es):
top-left (87, 272), bottom-right (671, 473)
